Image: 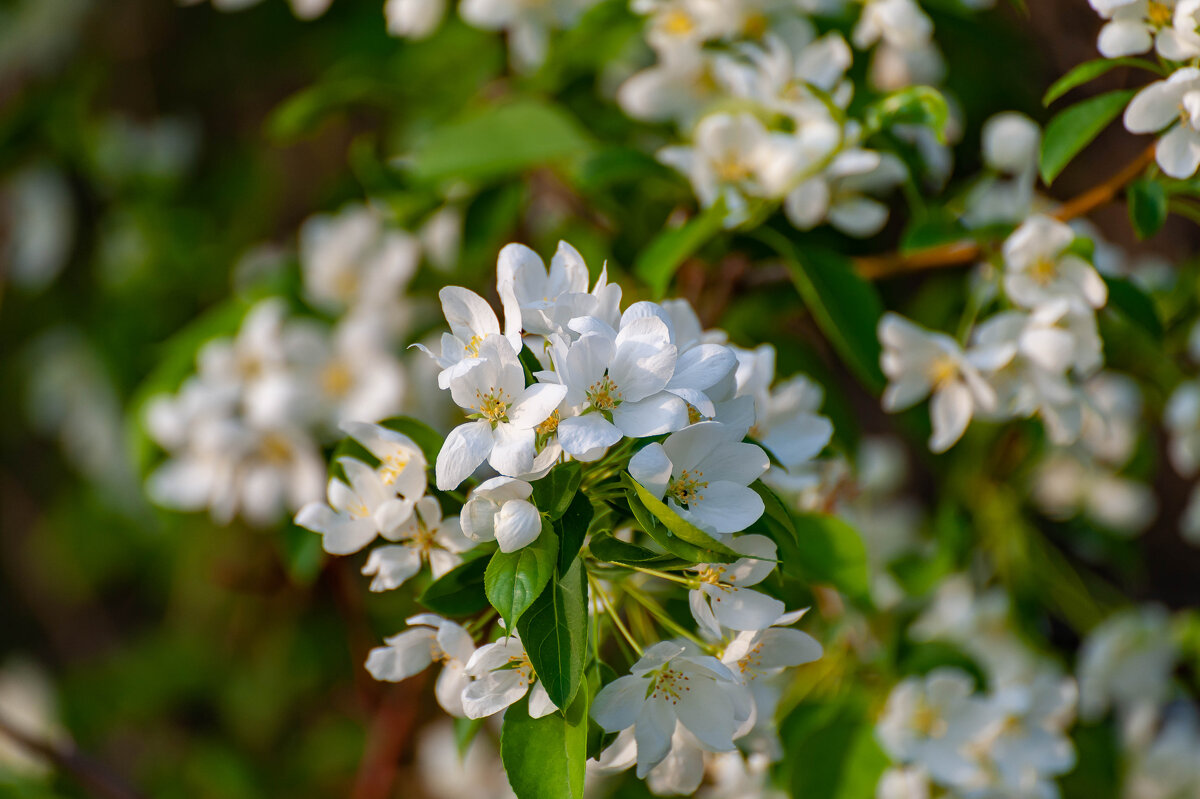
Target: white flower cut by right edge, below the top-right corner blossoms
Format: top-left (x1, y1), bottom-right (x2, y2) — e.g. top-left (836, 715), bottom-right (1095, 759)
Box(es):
top-left (1124, 67), bottom-right (1200, 180)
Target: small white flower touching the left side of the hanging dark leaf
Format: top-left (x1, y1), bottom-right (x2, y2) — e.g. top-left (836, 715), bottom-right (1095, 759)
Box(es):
top-left (462, 632), bottom-right (557, 719)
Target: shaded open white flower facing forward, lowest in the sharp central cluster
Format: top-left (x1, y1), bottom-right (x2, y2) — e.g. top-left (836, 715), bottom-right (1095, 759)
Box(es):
top-left (592, 641), bottom-right (754, 777)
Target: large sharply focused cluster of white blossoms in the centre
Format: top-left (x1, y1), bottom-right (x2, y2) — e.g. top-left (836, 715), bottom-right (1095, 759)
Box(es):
top-left (296, 242), bottom-right (833, 793)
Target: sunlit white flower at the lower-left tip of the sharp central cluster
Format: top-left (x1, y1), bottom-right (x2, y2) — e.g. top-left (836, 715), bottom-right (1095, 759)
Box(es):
top-left (366, 613), bottom-right (475, 717)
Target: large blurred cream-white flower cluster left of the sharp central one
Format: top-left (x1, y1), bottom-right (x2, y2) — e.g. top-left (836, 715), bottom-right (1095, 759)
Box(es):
top-left (145, 206), bottom-right (420, 524)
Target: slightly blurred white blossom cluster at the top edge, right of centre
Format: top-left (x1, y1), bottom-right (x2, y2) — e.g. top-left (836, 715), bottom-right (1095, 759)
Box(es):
top-left (617, 0), bottom-right (936, 236)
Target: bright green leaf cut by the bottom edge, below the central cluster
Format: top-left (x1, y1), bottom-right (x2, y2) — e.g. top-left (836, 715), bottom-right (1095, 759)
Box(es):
top-left (500, 691), bottom-right (588, 799)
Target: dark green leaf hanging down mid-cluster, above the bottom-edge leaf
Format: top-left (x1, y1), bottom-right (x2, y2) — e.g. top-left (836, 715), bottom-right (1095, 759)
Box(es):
top-left (517, 558), bottom-right (588, 709)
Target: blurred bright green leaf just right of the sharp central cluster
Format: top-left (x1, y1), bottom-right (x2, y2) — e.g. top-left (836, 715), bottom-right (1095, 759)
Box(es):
top-left (780, 513), bottom-right (870, 600)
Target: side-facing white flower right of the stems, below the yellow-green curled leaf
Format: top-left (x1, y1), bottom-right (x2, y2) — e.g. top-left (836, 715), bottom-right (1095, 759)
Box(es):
top-left (688, 534), bottom-right (784, 636)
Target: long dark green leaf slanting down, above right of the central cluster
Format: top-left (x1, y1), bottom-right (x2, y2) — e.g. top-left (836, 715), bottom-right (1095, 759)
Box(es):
top-left (756, 228), bottom-right (886, 394)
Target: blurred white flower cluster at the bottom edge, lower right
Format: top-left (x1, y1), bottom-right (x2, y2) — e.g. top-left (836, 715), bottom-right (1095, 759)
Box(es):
top-left (876, 576), bottom-right (1078, 799)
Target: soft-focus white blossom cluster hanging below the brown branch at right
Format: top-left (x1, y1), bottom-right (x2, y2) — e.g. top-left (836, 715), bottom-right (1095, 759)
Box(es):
top-left (878, 216), bottom-right (1108, 452)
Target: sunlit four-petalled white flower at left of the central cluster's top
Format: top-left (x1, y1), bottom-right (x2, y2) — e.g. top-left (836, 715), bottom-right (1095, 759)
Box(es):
top-left (434, 336), bottom-right (566, 491)
